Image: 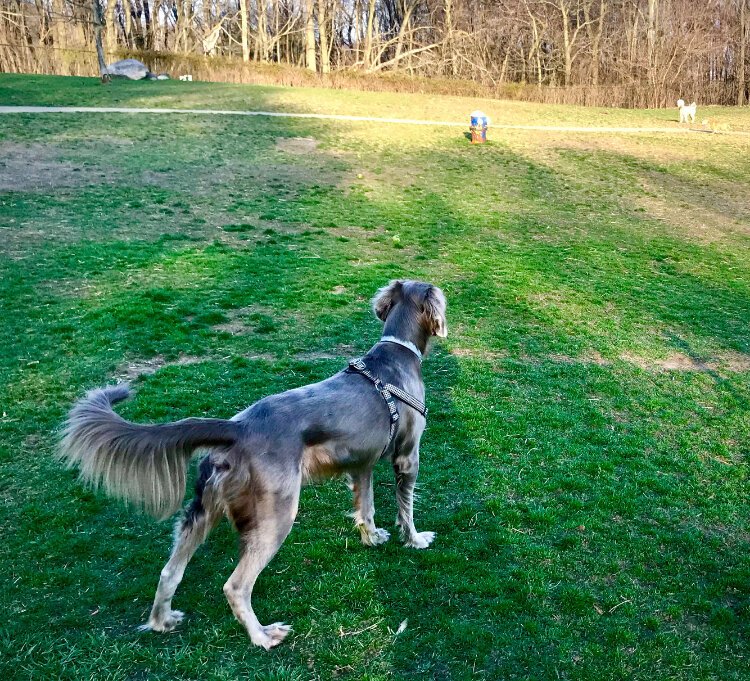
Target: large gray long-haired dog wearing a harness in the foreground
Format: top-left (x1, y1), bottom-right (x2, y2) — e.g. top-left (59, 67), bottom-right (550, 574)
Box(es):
top-left (61, 281), bottom-right (447, 649)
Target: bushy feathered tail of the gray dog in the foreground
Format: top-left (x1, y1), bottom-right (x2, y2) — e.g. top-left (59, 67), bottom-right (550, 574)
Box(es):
top-left (59, 384), bottom-right (239, 520)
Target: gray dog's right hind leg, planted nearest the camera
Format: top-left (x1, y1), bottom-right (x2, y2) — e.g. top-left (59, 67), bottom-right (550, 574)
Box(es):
top-left (224, 478), bottom-right (301, 650)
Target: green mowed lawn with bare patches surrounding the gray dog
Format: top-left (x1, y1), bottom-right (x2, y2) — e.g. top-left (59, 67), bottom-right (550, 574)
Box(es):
top-left (0, 76), bottom-right (750, 681)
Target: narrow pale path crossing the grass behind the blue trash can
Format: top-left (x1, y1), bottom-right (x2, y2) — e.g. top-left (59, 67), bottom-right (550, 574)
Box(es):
top-left (0, 106), bottom-right (750, 137)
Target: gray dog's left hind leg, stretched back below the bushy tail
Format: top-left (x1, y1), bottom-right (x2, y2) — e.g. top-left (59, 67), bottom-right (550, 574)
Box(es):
top-left (140, 457), bottom-right (222, 631)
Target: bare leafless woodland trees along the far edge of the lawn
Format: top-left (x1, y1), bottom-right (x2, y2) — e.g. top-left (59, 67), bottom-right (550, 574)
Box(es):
top-left (0, 0), bottom-right (750, 106)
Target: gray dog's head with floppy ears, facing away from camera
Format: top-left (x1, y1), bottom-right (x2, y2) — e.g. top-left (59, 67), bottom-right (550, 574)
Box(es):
top-left (372, 279), bottom-right (448, 338)
